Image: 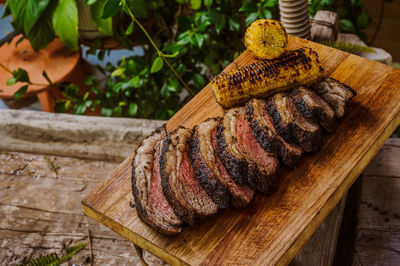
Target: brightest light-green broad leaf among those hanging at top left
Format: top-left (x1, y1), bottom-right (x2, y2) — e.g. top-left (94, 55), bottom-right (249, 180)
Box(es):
top-left (53, 0), bottom-right (78, 51)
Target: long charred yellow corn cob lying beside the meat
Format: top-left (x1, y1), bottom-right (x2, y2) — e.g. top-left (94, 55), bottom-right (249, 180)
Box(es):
top-left (211, 48), bottom-right (324, 108)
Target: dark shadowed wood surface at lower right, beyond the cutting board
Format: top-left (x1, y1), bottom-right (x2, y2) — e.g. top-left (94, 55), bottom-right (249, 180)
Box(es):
top-left (353, 139), bottom-right (400, 265)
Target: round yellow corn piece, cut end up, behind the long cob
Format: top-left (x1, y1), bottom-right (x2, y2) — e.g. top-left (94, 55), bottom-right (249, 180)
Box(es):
top-left (244, 19), bottom-right (288, 59)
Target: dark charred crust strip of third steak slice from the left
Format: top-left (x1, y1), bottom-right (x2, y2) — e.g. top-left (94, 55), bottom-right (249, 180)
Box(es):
top-left (189, 120), bottom-right (230, 208)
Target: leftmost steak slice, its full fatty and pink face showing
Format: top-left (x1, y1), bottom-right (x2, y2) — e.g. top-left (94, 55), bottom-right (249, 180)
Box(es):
top-left (132, 126), bottom-right (182, 235)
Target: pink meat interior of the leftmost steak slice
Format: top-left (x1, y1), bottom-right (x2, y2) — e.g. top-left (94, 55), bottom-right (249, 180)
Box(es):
top-left (150, 143), bottom-right (181, 225)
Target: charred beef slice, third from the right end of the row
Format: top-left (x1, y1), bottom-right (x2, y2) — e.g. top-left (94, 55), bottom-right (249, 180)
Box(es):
top-left (267, 93), bottom-right (321, 152)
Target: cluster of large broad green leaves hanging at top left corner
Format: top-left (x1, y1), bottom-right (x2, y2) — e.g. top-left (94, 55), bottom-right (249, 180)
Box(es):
top-left (4, 0), bottom-right (112, 50)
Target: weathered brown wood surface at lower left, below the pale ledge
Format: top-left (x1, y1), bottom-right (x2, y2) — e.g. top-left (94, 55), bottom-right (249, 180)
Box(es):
top-left (0, 152), bottom-right (163, 266)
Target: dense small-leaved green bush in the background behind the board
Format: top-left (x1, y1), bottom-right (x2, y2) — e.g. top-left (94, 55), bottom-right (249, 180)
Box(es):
top-left (1, 0), bottom-right (376, 119)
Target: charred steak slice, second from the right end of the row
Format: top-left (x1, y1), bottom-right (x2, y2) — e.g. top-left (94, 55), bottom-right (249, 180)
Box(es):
top-left (291, 86), bottom-right (337, 133)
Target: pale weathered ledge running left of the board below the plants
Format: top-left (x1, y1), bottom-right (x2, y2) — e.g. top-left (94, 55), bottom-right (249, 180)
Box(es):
top-left (0, 110), bottom-right (165, 162)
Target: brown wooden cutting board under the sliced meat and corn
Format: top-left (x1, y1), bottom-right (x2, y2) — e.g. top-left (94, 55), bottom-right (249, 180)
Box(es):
top-left (82, 37), bottom-right (400, 265)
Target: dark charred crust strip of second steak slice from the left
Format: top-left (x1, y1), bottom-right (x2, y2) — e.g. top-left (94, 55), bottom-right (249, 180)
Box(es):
top-left (160, 127), bottom-right (199, 225)
